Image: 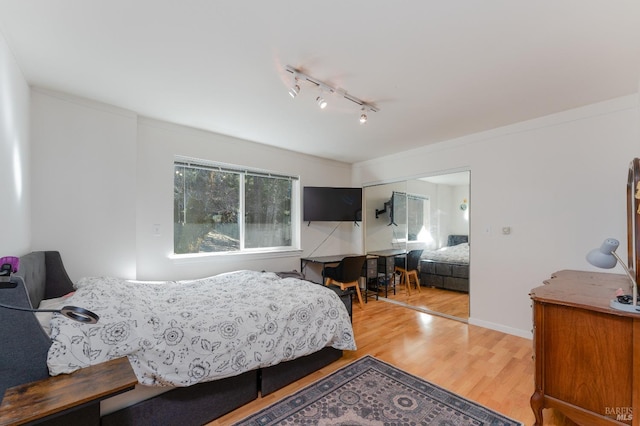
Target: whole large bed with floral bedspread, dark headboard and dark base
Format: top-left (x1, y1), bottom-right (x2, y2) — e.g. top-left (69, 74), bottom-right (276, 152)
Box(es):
top-left (0, 252), bottom-right (355, 426)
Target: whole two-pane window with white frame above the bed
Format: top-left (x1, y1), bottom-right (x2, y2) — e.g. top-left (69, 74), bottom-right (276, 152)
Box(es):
top-left (173, 159), bottom-right (299, 254)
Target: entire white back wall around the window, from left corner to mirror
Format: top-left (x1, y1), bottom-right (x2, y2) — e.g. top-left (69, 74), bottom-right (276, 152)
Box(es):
top-left (27, 88), bottom-right (352, 280)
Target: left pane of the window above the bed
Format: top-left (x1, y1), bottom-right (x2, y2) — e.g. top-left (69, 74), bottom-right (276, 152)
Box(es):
top-left (174, 165), bottom-right (240, 254)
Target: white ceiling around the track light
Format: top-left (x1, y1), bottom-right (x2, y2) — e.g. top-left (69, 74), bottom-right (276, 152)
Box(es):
top-left (0, 0), bottom-right (640, 163)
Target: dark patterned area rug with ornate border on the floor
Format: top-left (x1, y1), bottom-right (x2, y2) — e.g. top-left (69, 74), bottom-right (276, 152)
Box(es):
top-left (236, 355), bottom-right (521, 426)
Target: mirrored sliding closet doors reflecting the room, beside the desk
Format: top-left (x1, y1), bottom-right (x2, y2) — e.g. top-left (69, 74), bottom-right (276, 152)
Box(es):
top-left (364, 171), bottom-right (471, 320)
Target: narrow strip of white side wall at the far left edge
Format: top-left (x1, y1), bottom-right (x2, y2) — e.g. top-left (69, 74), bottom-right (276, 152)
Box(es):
top-left (0, 35), bottom-right (31, 257)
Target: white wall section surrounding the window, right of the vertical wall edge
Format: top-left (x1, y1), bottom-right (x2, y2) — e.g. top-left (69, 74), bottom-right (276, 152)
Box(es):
top-left (136, 118), bottom-right (354, 280)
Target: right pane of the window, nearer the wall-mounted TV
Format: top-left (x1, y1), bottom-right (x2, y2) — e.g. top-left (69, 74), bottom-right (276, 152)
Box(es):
top-left (244, 175), bottom-right (292, 249)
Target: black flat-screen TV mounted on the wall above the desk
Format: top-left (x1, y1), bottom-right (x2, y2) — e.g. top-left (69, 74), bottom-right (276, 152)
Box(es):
top-left (302, 186), bottom-right (362, 222)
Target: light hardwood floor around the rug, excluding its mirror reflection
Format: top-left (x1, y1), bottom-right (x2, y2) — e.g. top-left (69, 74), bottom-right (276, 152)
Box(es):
top-left (209, 294), bottom-right (568, 425)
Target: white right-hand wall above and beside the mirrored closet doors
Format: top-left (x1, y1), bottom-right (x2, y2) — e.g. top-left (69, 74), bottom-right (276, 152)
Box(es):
top-left (353, 95), bottom-right (640, 336)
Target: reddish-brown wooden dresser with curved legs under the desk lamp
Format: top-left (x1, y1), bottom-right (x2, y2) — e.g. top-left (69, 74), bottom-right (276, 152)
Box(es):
top-left (531, 271), bottom-right (640, 426)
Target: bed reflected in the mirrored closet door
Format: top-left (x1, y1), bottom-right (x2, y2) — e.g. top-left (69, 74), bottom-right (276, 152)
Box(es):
top-left (419, 235), bottom-right (469, 293)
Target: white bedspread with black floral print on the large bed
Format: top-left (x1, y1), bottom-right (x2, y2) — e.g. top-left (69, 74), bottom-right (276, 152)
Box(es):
top-left (47, 271), bottom-right (356, 386)
